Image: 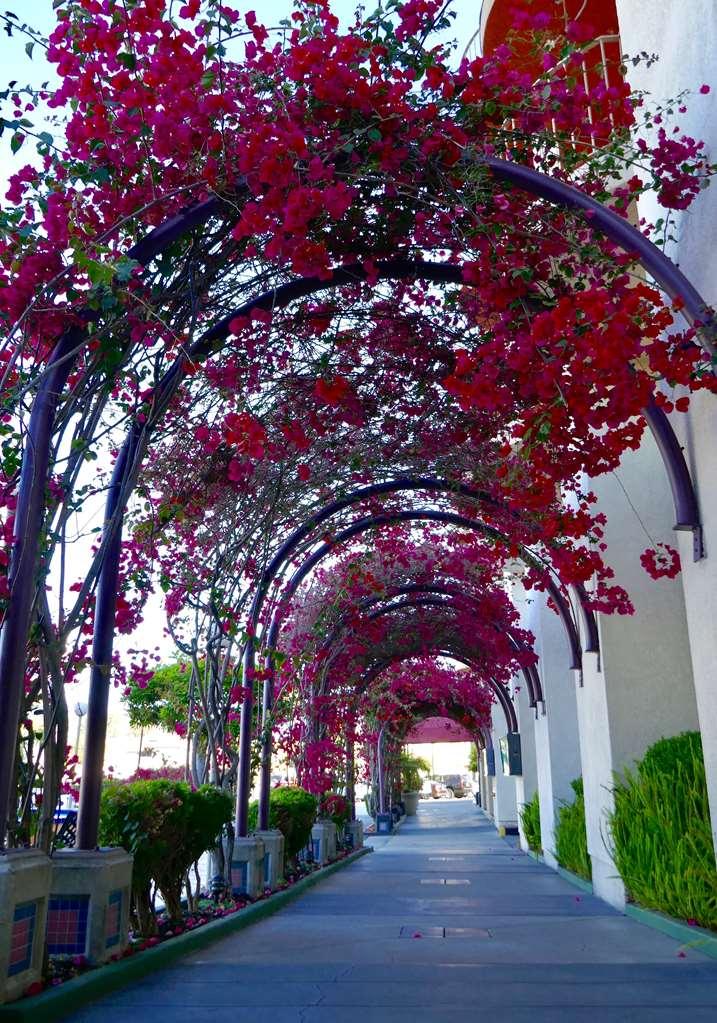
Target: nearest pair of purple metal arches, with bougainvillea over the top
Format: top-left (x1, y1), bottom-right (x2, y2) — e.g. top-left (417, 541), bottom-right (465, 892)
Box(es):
top-left (0, 157), bottom-right (703, 847)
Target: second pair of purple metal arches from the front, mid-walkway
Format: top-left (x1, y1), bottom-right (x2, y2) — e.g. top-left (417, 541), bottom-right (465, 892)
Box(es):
top-left (251, 503), bottom-right (568, 837)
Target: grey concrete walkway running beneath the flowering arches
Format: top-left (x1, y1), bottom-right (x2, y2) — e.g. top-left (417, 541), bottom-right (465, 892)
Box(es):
top-left (64, 800), bottom-right (717, 1023)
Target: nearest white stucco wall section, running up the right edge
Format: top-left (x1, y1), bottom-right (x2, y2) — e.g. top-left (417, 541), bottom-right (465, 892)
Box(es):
top-left (617, 0), bottom-right (717, 848)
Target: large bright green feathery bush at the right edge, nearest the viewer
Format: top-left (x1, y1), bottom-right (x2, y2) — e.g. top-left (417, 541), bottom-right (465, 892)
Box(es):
top-left (610, 731), bottom-right (717, 930)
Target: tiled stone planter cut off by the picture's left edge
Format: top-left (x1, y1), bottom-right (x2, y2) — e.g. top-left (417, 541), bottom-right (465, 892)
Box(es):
top-left (0, 849), bottom-right (52, 1002)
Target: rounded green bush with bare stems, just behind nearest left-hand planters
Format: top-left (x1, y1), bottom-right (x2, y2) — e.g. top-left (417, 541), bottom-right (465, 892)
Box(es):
top-left (99, 779), bottom-right (232, 936)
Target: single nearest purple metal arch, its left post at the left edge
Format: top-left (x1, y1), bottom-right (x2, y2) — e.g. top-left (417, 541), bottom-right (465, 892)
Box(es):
top-left (0, 148), bottom-right (715, 849)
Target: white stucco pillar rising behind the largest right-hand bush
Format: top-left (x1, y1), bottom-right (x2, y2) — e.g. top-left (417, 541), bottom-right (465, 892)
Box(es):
top-left (577, 435), bottom-right (698, 905)
